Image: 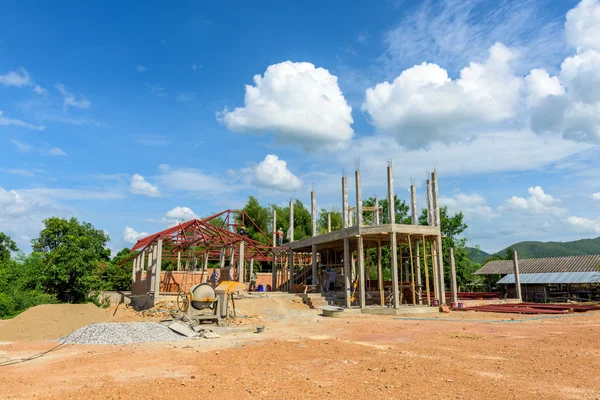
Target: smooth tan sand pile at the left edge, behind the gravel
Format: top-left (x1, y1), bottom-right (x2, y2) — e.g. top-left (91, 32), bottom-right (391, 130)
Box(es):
top-left (0, 303), bottom-right (110, 342)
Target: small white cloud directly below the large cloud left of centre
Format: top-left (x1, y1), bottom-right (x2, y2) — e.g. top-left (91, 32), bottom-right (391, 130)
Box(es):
top-left (253, 154), bottom-right (302, 192)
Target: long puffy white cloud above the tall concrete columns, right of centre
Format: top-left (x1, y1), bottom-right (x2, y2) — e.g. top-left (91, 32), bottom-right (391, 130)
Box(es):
top-left (361, 43), bottom-right (522, 148)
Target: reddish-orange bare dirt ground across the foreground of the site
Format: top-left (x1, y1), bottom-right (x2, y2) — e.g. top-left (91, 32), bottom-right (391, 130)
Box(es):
top-left (0, 298), bottom-right (600, 400)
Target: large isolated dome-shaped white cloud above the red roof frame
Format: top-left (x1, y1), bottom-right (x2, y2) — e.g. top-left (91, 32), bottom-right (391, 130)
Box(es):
top-left (217, 61), bottom-right (354, 147)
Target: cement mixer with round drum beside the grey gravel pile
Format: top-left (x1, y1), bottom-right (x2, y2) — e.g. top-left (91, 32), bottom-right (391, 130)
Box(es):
top-left (177, 281), bottom-right (245, 326)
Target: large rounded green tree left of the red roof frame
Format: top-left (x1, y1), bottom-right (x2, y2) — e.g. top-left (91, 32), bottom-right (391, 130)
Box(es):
top-left (32, 217), bottom-right (110, 302)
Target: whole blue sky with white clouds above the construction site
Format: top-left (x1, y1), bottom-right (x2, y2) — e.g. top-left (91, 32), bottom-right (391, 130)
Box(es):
top-left (0, 0), bottom-right (600, 255)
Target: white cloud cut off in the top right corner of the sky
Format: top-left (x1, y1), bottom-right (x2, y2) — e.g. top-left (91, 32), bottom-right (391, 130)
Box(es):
top-left (565, 0), bottom-right (600, 51)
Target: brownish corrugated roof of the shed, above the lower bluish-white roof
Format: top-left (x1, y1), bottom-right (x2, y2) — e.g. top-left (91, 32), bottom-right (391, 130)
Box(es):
top-left (475, 255), bottom-right (600, 275)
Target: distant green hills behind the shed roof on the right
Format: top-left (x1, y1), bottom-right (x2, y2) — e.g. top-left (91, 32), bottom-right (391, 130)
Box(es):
top-left (469, 237), bottom-right (600, 264)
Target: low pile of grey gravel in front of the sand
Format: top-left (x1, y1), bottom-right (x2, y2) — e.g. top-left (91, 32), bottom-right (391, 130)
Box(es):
top-left (65, 322), bottom-right (187, 344)
